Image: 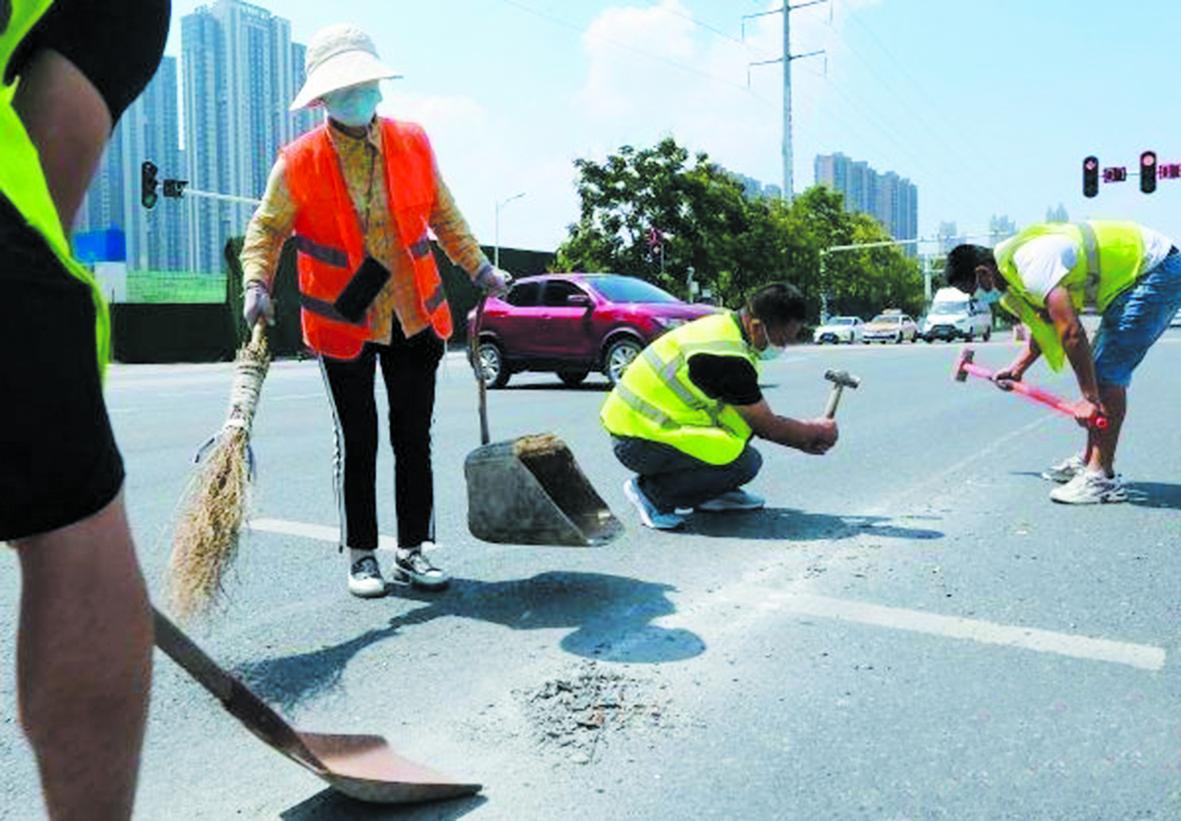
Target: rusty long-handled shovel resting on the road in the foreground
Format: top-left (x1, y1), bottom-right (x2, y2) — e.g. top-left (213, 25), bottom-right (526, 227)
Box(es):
top-left (152, 610), bottom-right (481, 804)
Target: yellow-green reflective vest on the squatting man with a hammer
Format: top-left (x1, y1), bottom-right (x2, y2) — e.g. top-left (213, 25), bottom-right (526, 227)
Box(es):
top-left (599, 311), bottom-right (758, 464)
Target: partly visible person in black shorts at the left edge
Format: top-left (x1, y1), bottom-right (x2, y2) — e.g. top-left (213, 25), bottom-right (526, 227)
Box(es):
top-left (0, 0), bottom-right (171, 820)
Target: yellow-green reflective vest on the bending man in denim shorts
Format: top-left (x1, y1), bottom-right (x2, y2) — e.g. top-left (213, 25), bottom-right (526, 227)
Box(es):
top-left (996, 220), bottom-right (1144, 371)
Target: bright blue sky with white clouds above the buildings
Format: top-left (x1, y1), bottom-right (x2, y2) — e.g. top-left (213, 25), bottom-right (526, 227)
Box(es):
top-left (169, 0), bottom-right (1181, 248)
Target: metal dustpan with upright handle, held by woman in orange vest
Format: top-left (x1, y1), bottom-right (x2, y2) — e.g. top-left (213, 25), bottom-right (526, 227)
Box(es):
top-left (463, 297), bottom-right (624, 547)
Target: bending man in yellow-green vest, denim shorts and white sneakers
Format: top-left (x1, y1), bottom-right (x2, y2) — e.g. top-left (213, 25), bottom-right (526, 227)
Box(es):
top-left (946, 221), bottom-right (1181, 504)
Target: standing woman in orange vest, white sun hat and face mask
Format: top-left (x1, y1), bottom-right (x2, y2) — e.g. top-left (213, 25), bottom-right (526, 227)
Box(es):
top-left (241, 25), bottom-right (511, 598)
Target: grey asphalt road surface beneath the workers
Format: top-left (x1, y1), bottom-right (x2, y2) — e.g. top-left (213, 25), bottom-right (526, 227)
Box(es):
top-left (0, 332), bottom-right (1181, 821)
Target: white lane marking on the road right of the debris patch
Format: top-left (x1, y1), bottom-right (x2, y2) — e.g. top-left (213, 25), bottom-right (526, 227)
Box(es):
top-left (763, 593), bottom-right (1164, 672)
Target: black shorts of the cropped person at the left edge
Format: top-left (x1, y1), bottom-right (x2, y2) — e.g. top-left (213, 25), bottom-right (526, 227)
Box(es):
top-left (0, 196), bottom-right (123, 542)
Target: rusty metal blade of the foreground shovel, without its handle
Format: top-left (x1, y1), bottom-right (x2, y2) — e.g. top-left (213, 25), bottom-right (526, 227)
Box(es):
top-left (299, 732), bottom-right (481, 804)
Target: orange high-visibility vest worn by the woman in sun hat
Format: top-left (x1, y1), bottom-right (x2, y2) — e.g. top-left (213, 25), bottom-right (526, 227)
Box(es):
top-left (282, 118), bottom-right (451, 359)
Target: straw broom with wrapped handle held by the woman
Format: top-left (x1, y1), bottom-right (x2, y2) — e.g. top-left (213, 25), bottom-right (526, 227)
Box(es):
top-left (168, 320), bottom-right (270, 620)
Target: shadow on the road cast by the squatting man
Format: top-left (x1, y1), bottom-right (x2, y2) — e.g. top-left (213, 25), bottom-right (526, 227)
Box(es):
top-left (681, 508), bottom-right (944, 541)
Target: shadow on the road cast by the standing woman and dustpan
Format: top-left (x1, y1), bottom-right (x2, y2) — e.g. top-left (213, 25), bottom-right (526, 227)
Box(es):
top-left (235, 573), bottom-right (705, 710)
